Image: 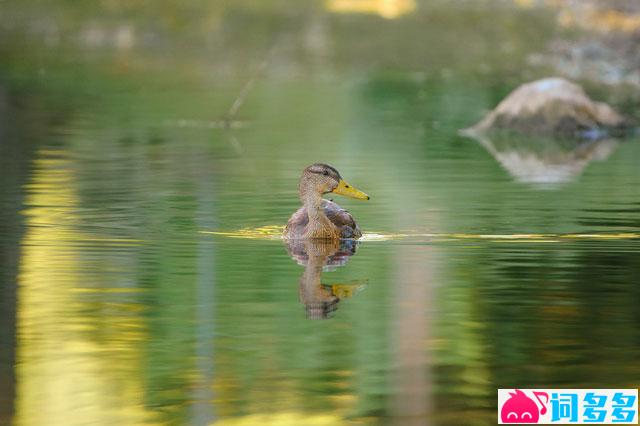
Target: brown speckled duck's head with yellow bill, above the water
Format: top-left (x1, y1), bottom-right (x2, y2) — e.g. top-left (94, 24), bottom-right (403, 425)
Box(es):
top-left (300, 164), bottom-right (370, 200)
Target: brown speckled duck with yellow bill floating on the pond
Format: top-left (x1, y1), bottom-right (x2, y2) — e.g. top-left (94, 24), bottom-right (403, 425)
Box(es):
top-left (284, 163), bottom-right (371, 240)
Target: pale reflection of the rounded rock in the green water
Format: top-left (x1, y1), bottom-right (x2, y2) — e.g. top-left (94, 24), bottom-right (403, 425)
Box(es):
top-left (467, 134), bottom-right (618, 185)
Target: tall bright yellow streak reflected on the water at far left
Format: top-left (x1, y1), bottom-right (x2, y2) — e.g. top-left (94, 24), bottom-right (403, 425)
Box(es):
top-left (14, 151), bottom-right (158, 426)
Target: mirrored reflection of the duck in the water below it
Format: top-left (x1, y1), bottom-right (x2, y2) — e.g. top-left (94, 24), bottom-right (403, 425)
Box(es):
top-left (286, 239), bottom-right (366, 319)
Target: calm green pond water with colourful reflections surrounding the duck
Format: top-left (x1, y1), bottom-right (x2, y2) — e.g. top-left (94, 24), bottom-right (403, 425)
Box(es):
top-left (0, 2), bottom-right (640, 425)
